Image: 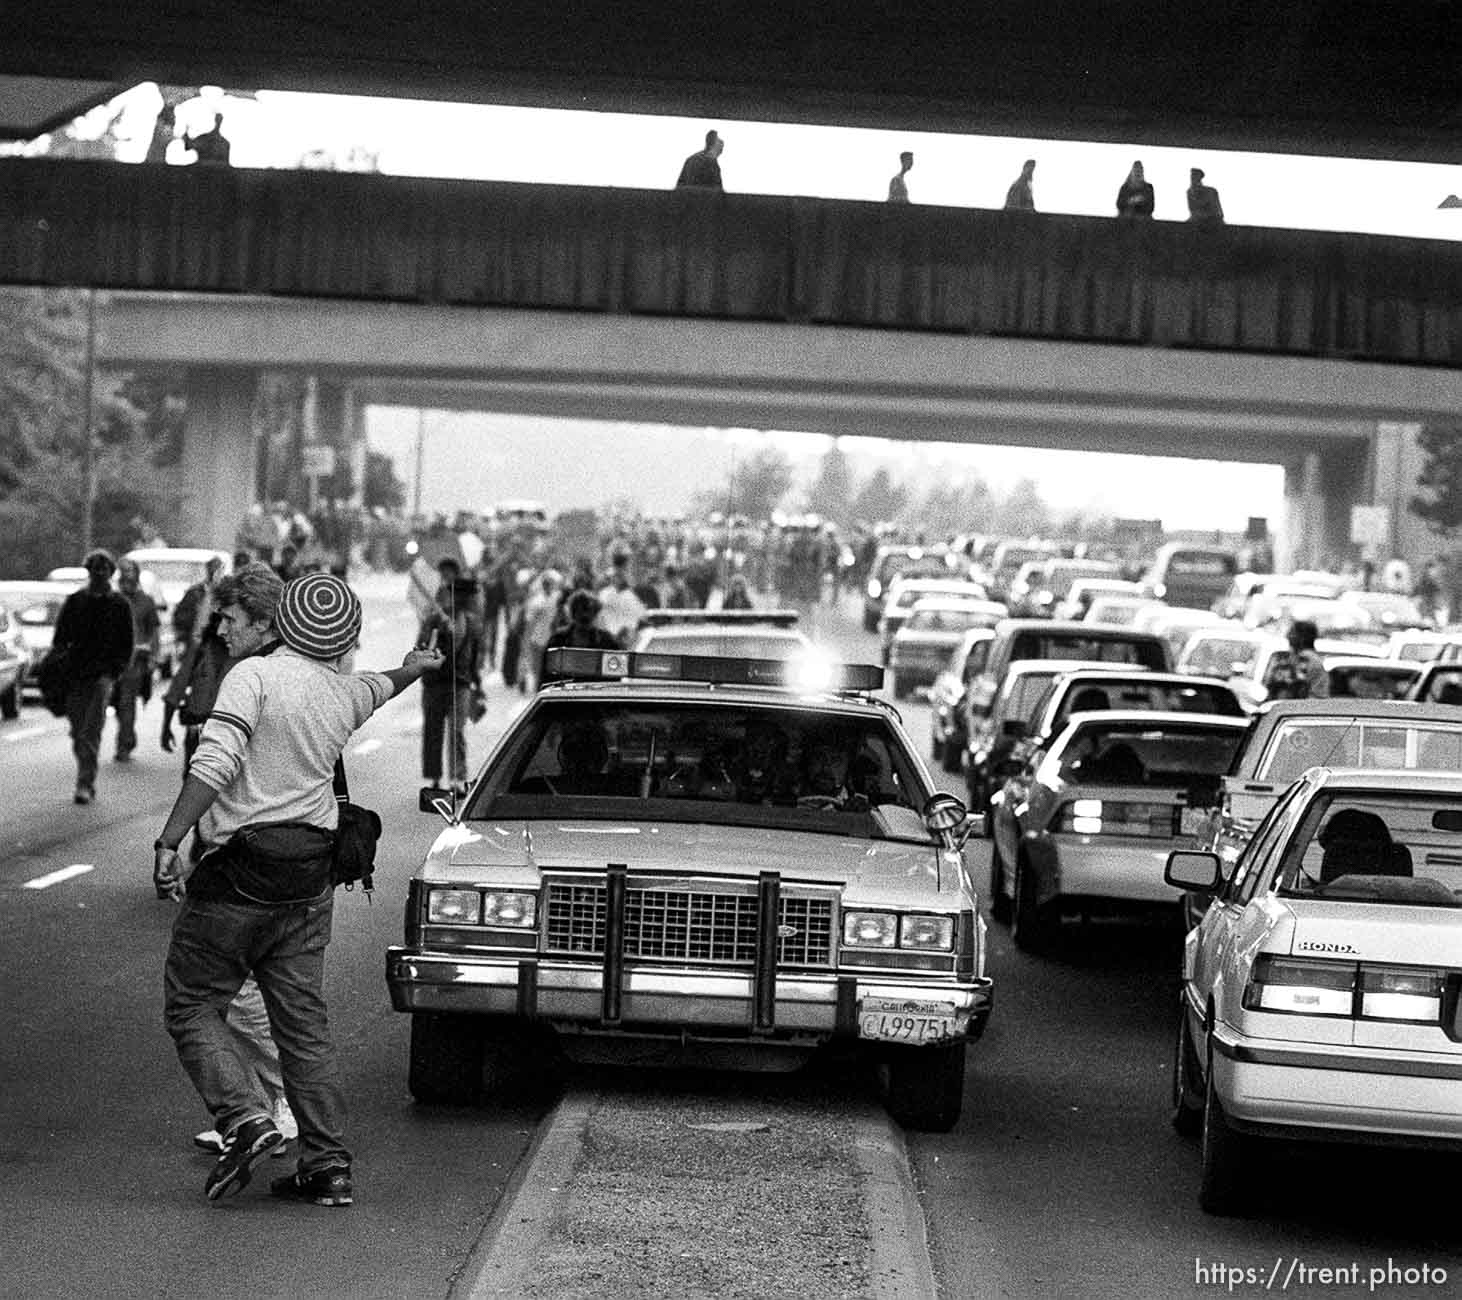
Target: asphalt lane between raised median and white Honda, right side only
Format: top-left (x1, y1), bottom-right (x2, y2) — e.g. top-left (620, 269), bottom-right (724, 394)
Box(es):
top-left (827, 608), bottom-right (1462, 1300)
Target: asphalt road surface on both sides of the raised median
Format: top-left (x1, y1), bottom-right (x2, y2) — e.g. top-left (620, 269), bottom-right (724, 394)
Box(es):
top-left (0, 579), bottom-right (1462, 1300)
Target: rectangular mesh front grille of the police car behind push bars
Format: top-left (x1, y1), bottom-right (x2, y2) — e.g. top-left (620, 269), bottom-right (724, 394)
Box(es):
top-left (544, 883), bottom-right (833, 967)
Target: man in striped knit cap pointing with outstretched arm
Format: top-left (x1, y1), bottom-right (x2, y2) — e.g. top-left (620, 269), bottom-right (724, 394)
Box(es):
top-left (152, 573), bottom-right (442, 1206)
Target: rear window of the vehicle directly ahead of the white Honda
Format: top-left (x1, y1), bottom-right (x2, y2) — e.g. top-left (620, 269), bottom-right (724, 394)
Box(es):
top-left (1254, 718), bottom-right (1462, 785)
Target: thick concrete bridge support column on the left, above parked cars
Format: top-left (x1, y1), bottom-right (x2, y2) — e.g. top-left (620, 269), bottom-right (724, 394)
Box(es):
top-left (184, 367), bottom-right (257, 551)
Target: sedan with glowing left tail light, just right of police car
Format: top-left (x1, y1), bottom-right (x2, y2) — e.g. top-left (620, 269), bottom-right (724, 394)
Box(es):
top-left (990, 711), bottom-right (1247, 951)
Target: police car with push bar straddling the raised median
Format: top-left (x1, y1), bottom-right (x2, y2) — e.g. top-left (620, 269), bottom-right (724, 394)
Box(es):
top-left (386, 649), bottom-right (993, 1130)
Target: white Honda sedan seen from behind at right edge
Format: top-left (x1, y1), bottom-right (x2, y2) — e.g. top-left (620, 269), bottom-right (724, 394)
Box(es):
top-left (1165, 768), bottom-right (1462, 1214)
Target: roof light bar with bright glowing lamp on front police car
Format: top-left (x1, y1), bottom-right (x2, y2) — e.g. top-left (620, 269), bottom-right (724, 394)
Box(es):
top-left (544, 646), bottom-right (883, 692)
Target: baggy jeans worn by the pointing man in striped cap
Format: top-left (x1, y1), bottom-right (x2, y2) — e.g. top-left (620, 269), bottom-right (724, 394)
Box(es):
top-left (164, 891), bottom-right (351, 1174)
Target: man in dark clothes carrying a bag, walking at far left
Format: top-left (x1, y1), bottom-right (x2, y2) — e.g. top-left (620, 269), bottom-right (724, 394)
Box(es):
top-left (51, 550), bottom-right (133, 803)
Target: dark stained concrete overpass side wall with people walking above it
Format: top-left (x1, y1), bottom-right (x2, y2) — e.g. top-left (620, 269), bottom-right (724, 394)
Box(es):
top-left (0, 159), bottom-right (1462, 366)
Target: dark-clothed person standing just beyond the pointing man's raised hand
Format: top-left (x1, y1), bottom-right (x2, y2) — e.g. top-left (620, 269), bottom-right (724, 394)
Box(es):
top-left (417, 556), bottom-right (482, 796)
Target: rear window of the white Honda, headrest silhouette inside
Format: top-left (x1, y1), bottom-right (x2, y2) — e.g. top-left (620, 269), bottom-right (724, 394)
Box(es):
top-left (1279, 791), bottom-right (1462, 907)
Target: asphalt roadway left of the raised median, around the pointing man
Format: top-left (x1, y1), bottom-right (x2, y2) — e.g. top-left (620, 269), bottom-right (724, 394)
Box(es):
top-left (0, 579), bottom-right (542, 1300)
